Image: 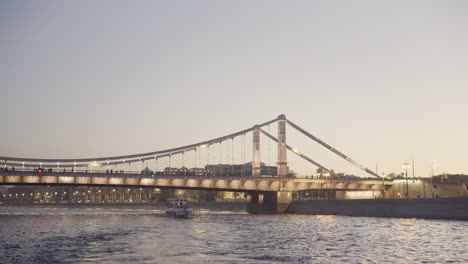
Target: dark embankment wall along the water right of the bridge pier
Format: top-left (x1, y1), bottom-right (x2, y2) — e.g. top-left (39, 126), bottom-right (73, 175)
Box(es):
top-left (287, 198), bottom-right (468, 220)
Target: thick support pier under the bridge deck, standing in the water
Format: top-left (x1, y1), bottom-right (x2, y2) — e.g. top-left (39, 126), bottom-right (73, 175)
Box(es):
top-left (247, 191), bottom-right (292, 214)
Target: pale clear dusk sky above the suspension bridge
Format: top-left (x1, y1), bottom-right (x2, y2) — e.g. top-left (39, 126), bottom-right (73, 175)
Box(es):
top-left (0, 0), bottom-right (468, 177)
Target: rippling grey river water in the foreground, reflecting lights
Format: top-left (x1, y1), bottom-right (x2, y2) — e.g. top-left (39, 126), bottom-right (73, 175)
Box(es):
top-left (0, 207), bottom-right (468, 263)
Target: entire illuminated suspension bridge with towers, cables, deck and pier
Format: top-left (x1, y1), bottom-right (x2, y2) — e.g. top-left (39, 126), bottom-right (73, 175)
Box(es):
top-left (0, 115), bottom-right (392, 213)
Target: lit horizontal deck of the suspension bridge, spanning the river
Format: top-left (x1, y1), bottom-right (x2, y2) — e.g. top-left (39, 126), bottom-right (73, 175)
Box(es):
top-left (0, 171), bottom-right (393, 192)
